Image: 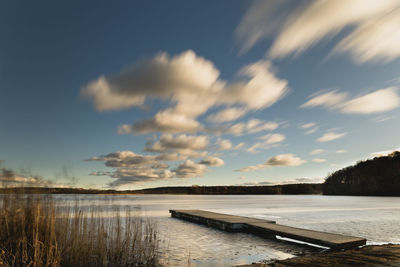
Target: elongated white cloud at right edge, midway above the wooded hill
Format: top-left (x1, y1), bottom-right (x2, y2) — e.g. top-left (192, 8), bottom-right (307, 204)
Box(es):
top-left (300, 87), bottom-right (400, 114)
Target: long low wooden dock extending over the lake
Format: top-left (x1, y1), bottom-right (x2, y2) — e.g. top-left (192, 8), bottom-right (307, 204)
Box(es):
top-left (169, 210), bottom-right (367, 249)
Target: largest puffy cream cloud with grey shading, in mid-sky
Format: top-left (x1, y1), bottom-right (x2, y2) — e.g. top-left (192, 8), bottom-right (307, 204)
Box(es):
top-left (81, 50), bottom-right (289, 134)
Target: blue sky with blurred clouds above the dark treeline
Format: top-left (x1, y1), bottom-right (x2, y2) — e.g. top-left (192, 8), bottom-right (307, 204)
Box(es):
top-left (0, 0), bottom-right (400, 189)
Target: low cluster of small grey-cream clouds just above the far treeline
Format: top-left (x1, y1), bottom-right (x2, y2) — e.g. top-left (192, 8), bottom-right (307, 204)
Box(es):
top-left (87, 138), bottom-right (224, 187)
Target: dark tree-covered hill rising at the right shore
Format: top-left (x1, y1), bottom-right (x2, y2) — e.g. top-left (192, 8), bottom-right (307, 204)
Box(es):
top-left (323, 151), bottom-right (400, 196)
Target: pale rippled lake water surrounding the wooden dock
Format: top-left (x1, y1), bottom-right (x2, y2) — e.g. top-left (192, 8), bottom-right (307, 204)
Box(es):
top-left (57, 195), bottom-right (400, 266)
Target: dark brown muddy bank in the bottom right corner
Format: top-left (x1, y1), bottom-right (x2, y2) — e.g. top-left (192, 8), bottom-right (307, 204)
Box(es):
top-left (242, 244), bottom-right (400, 267)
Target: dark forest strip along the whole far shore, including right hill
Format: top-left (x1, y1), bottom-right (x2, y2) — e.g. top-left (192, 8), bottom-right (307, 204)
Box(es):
top-left (0, 151), bottom-right (400, 196)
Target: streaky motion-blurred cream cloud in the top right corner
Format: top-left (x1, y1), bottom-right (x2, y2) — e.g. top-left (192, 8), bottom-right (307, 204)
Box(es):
top-left (235, 0), bottom-right (400, 63)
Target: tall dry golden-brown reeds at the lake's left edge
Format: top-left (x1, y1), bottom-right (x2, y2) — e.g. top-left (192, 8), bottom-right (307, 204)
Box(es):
top-left (0, 194), bottom-right (160, 267)
